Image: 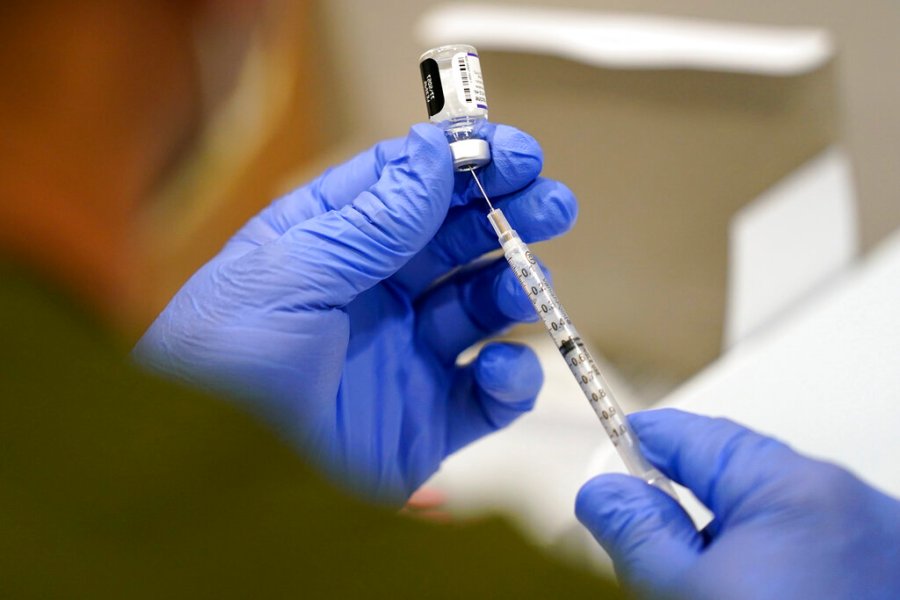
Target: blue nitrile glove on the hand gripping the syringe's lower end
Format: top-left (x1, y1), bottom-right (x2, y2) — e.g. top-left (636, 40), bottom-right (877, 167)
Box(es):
top-left (576, 409), bottom-right (900, 600)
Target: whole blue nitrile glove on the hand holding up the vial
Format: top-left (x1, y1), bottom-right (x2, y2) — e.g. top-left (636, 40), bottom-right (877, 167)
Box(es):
top-left (135, 125), bottom-right (576, 501)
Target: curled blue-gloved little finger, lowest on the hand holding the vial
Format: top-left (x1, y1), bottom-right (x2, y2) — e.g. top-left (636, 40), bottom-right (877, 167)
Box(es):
top-left (447, 343), bottom-right (544, 454)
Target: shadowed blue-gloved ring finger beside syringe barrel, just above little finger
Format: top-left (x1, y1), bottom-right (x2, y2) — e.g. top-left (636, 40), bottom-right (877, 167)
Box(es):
top-left (416, 259), bottom-right (537, 364)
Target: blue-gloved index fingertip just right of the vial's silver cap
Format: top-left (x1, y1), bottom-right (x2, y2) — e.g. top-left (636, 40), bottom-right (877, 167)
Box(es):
top-left (453, 123), bottom-right (544, 205)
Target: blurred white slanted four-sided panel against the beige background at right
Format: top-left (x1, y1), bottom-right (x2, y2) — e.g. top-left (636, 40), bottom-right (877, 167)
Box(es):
top-left (724, 147), bottom-right (859, 348)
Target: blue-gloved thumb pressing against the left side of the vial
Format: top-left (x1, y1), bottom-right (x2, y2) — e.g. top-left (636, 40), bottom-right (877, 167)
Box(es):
top-left (232, 125), bottom-right (453, 309)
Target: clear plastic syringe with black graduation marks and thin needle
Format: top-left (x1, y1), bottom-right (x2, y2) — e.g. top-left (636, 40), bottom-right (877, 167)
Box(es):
top-left (468, 168), bottom-right (678, 500)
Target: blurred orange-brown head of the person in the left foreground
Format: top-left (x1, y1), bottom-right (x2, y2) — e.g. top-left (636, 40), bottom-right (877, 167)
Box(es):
top-left (0, 0), bottom-right (263, 324)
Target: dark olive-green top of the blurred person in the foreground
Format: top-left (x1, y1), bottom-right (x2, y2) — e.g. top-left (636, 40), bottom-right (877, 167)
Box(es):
top-left (0, 266), bottom-right (621, 600)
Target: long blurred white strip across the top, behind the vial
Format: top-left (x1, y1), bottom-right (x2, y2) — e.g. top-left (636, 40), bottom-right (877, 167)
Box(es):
top-left (416, 2), bottom-right (834, 76)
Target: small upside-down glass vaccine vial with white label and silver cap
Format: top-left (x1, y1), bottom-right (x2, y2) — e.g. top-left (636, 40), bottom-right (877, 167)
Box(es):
top-left (419, 44), bottom-right (491, 171)
